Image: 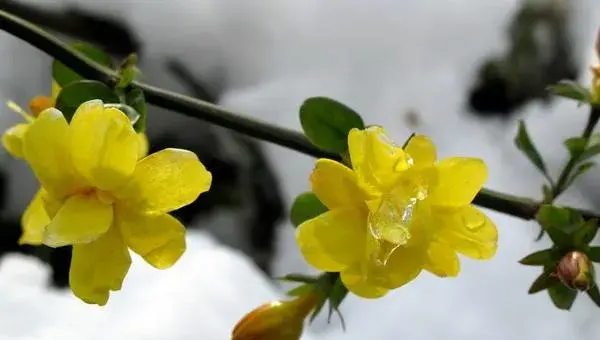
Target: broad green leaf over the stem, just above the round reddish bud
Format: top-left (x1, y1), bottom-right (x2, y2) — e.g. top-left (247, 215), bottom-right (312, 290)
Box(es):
top-left (536, 204), bottom-right (584, 248)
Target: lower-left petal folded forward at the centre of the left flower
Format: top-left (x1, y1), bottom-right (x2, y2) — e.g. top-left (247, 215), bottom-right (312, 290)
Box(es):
top-left (44, 194), bottom-right (113, 247)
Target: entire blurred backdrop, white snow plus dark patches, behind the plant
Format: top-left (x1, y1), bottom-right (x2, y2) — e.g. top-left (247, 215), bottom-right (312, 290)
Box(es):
top-left (0, 0), bottom-right (600, 340)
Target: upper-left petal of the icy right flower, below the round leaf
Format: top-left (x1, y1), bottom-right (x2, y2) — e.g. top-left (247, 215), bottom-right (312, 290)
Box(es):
top-left (310, 159), bottom-right (364, 210)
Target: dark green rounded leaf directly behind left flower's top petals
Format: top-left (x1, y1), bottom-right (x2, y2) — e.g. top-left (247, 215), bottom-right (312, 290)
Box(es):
top-left (56, 80), bottom-right (119, 121)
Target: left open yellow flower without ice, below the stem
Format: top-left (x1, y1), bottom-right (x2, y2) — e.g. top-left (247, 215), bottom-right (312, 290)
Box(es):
top-left (22, 100), bottom-right (212, 305)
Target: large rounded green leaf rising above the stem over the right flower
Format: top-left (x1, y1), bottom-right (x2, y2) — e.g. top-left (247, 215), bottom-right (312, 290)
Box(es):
top-left (300, 97), bottom-right (365, 153)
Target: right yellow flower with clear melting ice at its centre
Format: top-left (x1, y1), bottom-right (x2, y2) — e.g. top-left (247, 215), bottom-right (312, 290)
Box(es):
top-left (296, 127), bottom-right (498, 298)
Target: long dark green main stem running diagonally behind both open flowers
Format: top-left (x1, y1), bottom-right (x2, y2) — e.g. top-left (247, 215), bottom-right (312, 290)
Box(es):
top-left (0, 10), bottom-right (600, 220)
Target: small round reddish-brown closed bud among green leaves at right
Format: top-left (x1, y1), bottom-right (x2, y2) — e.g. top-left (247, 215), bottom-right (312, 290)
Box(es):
top-left (555, 251), bottom-right (594, 291)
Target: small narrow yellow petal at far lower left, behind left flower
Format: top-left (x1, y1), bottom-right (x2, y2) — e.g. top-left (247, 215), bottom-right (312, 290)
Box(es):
top-left (19, 189), bottom-right (50, 245)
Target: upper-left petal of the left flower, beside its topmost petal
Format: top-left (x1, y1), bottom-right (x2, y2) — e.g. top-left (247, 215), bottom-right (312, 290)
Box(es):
top-left (23, 108), bottom-right (83, 197)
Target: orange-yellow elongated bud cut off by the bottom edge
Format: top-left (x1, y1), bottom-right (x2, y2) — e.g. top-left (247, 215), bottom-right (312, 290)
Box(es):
top-left (231, 290), bottom-right (318, 340)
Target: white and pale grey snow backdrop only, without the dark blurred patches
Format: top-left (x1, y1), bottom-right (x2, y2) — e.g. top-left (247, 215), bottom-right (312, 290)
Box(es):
top-left (0, 0), bottom-right (600, 340)
